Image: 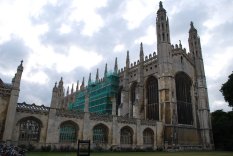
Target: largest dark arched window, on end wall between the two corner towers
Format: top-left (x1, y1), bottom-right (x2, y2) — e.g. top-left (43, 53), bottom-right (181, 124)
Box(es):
top-left (175, 72), bottom-right (193, 125)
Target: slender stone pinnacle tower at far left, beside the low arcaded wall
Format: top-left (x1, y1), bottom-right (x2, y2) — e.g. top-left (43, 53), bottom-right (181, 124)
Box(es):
top-left (3, 61), bottom-right (23, 141)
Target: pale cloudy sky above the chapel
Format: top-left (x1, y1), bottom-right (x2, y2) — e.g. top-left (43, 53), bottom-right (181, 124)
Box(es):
top-left (0, 0), bottom-right (233, 111)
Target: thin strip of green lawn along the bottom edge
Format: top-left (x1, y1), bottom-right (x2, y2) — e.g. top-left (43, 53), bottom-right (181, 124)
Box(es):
top-left (26, 152), bottom-right (233, 156)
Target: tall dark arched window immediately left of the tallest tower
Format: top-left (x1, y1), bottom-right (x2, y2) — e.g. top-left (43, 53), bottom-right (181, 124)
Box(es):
top-left (146, 76), bottom-right (159, 120)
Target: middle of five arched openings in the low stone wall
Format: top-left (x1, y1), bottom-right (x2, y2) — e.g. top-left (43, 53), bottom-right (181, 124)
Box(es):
top-left (93, 124), bottom-right (108, 144)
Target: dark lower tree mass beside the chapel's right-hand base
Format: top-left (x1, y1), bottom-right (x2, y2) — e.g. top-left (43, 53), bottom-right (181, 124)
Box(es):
top-left (211, 110), bottom-right (233, 151)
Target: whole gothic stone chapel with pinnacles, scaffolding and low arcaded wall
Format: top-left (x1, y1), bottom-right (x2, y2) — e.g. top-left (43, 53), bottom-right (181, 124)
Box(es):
top-left (0, 2), bottom-right (213, 149)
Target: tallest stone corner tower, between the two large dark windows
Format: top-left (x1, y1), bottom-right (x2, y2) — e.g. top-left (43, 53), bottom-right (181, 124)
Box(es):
top-left (156, 2), bottom-right (176, 144)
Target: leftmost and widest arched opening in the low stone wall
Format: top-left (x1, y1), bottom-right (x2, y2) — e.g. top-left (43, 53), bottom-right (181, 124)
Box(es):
top-left (19, 118), bottom-right (41, 142)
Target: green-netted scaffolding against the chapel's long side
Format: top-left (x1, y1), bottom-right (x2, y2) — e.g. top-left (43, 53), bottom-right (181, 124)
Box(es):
top-left (68, 73), bottom-right (119, 114)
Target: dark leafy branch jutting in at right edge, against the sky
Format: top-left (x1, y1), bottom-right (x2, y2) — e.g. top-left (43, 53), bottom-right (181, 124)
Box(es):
top-left (220, 73), bottom-right (233, 107)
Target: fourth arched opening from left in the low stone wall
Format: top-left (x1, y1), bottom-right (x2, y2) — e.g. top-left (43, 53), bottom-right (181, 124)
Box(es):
top-left (120, 127), bottom-right (133, 145)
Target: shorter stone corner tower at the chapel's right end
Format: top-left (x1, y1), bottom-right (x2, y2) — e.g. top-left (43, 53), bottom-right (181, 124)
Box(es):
top-left (188, 22), bottom-right (213, 149)
